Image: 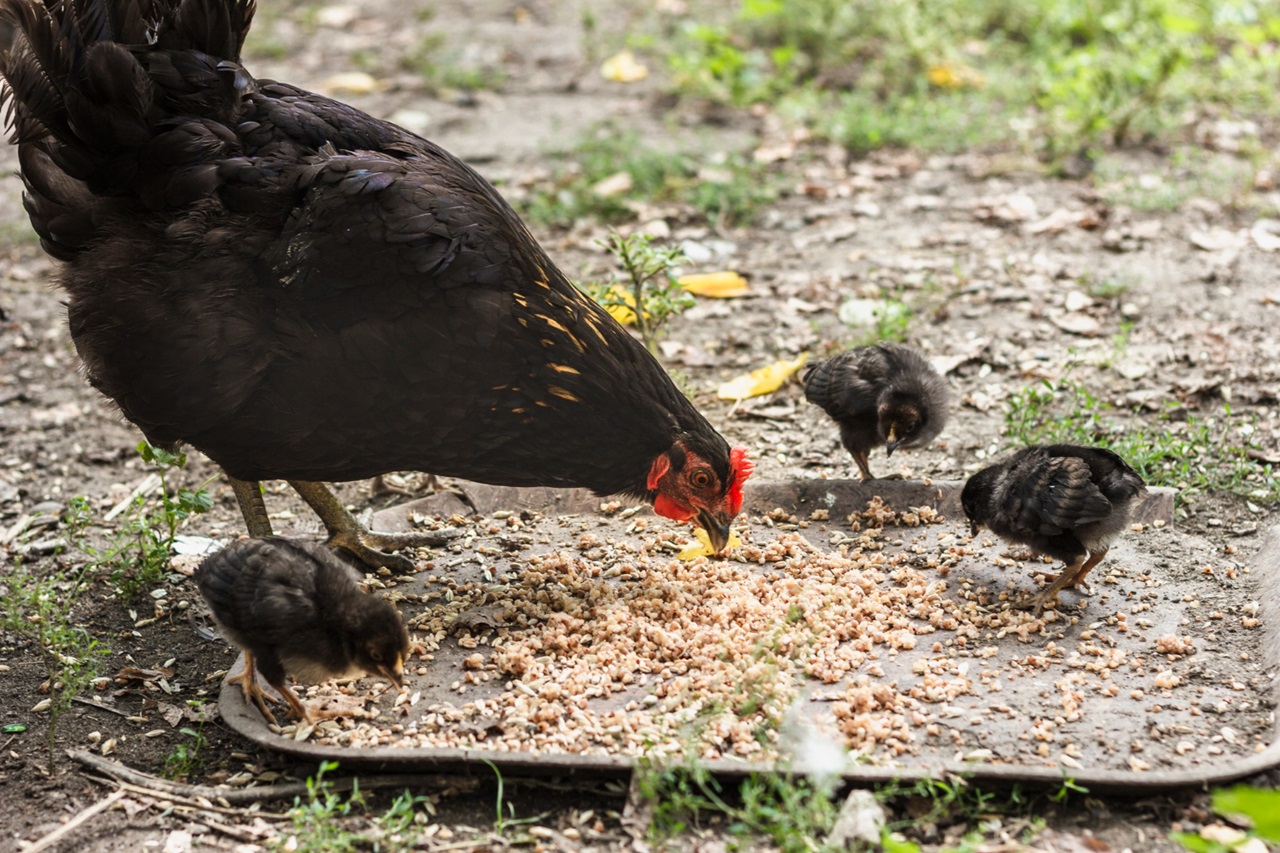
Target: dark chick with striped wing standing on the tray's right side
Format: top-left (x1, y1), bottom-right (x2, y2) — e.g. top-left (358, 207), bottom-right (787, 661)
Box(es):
top-left (960, 444), bottom-right (1147, 615)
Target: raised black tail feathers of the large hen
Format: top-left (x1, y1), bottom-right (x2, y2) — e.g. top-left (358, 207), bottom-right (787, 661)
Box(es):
top-left (0, 0), bottom-right (255, 253)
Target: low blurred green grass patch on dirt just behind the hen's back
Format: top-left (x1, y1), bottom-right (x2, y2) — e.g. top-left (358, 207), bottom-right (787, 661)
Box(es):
top-left (517, 126), bottom-right (777, 227)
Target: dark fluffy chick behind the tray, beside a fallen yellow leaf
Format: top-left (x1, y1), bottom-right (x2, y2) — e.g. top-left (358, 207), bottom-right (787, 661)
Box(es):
top-left (804, 343), bottom-right (951, 480)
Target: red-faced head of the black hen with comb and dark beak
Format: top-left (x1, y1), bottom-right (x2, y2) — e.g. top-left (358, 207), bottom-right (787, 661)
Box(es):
top-left (646, 439), bottom-right (755, 551)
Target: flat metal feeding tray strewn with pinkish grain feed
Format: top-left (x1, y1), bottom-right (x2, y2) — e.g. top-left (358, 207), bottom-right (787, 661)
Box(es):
top-left (219, 480), bottom-right (1280, 790)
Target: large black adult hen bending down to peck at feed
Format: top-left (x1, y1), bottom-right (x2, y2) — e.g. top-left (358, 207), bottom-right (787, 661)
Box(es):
top-left (0, 0), bottom-right (750, 567)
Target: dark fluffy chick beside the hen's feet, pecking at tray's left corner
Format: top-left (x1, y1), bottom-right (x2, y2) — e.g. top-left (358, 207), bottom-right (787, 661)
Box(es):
top-left (195, 537), bottom-right (410, 722)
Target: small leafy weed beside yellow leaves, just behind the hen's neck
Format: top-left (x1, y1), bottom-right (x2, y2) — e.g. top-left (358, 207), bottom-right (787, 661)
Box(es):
top-left (586, 231), bottom-right (696, 352)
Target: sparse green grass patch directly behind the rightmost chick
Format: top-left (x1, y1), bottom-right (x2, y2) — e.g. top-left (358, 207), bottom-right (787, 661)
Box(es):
top-left (1004, 378), bottom-right (1280, 501)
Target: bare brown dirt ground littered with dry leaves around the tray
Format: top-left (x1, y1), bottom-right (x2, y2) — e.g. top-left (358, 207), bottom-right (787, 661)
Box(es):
top-left (0, 0), bottom-right (1280, 852)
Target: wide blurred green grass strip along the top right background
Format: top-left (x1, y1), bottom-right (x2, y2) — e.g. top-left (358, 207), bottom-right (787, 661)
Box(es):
top-left (655, 0), bottom-right (1280, 160)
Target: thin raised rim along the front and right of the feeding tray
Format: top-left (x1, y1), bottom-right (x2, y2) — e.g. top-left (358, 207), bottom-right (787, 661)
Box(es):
top-left (218, 489), bottom-right (1280, 794)
